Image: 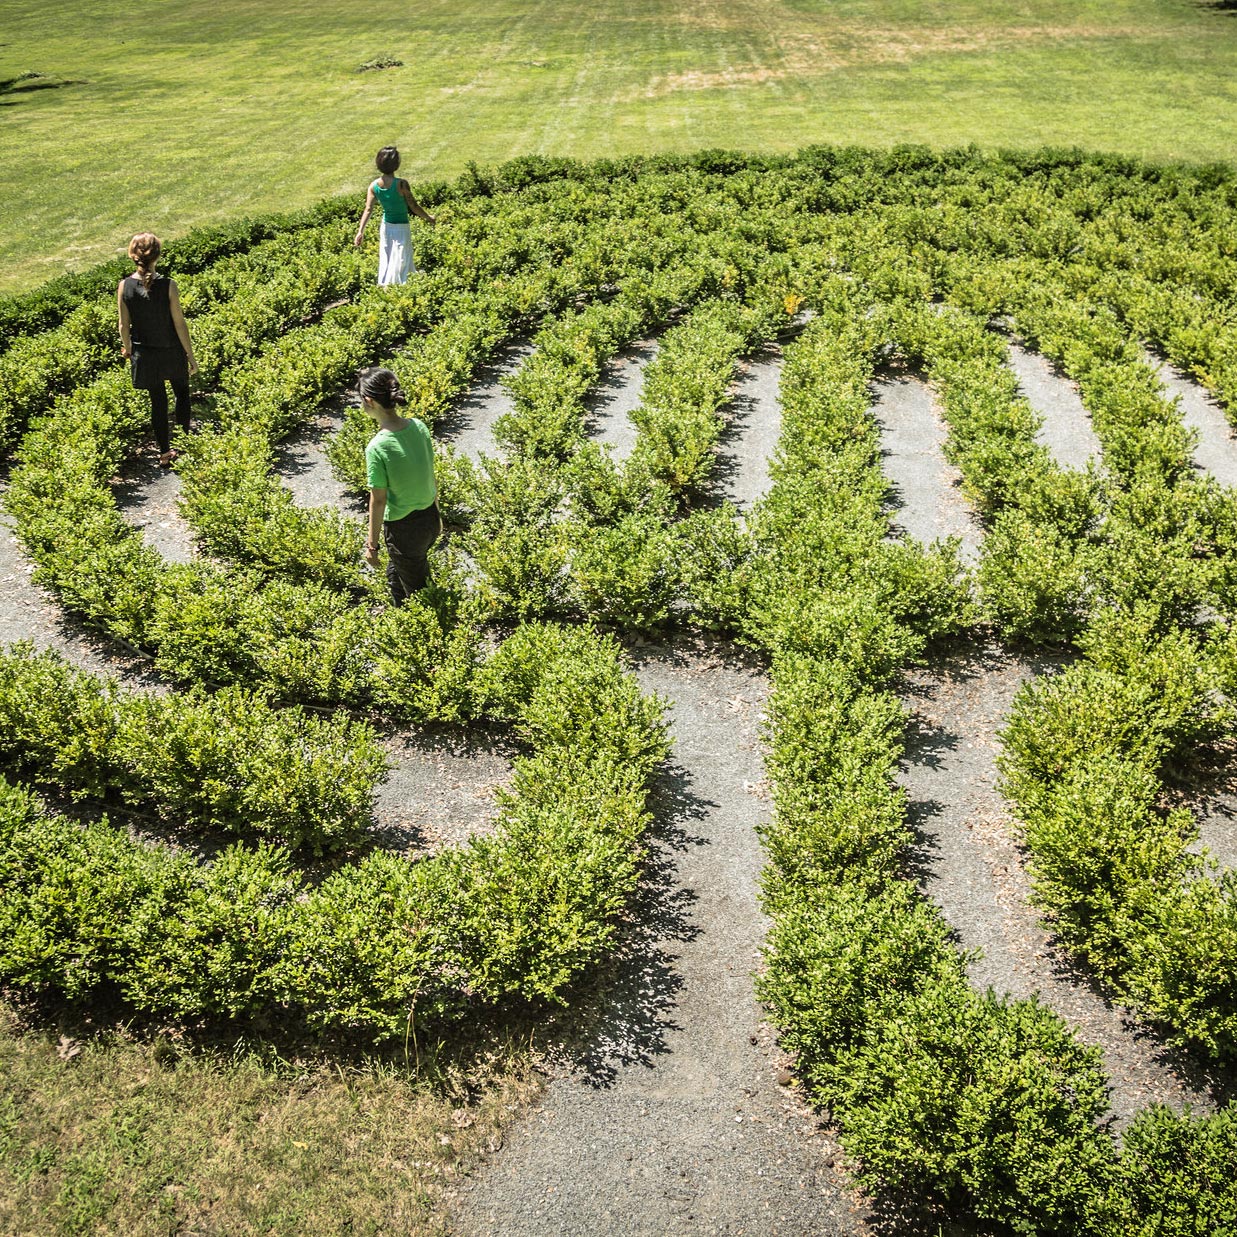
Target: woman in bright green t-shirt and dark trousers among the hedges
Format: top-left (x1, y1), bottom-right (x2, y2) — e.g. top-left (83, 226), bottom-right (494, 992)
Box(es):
top-left (361, 370), bottom-right (443, 606)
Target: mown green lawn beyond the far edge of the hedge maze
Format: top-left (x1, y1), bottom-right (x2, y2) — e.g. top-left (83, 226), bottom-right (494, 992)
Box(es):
top-left (0, 0), bottom-right (1237, 291)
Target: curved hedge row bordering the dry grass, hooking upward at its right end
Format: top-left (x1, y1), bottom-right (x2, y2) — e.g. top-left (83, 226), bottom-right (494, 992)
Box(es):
top-left (0, 627), bottom-right (667, 1039)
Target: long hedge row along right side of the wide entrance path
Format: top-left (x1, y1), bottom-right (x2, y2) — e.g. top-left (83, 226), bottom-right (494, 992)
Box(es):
top-left (755, 275), bottom-right (1237, 1235)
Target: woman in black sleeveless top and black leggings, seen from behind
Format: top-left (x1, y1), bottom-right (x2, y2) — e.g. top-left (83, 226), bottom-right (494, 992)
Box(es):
top-left (116, 233), bottom-right (198, 468)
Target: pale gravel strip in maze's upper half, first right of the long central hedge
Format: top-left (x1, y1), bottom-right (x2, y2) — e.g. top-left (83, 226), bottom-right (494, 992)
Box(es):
top-left (872, 377), bottom-right (981, 563)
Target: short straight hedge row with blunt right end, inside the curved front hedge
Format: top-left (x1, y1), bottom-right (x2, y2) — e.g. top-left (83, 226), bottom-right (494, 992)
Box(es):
top-left (0, 643), bottom-right (387, 855)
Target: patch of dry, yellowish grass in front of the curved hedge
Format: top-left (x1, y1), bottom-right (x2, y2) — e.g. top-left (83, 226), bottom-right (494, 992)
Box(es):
top-left (0, 1004), bottom-right (537, 1237)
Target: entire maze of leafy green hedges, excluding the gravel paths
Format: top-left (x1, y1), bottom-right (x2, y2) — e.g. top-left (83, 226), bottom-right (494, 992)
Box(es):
top-left (0, 148), bottom-right (1237, 1237)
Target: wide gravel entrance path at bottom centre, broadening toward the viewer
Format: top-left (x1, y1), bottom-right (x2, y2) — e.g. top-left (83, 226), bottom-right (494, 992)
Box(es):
top-left (454, 649), bottom-right (868, 1237)
